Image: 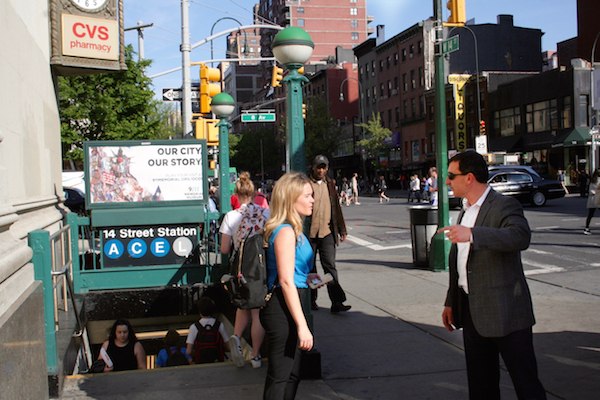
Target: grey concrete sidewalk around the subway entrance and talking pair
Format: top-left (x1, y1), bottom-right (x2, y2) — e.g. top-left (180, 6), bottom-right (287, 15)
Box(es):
top-left (62, 198), bottom-right (600, 400)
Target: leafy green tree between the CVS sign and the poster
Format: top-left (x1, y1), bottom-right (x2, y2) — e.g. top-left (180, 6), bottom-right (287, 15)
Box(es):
top-left (58, 45), bottom-right (176, 161)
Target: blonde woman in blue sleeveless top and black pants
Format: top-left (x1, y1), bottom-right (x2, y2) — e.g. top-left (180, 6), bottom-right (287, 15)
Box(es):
top-left (260, 172), bottom-right (321, 399)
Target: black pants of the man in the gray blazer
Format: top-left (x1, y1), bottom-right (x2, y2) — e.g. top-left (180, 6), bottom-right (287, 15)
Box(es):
top-left (461, 292), bottom-right (546, 400)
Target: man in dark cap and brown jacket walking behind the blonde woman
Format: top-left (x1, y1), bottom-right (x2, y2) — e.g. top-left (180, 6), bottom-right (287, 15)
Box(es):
top-left (306, 155), bottom-right (351, 313)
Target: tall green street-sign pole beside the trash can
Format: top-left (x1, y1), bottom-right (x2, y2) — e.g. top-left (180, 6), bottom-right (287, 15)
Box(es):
top-left (432, 0), bottom-right (450, 271)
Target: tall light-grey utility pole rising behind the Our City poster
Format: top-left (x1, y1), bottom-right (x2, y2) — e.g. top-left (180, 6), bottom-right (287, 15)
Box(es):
top-left (180, 0), bottom-right (193, 138)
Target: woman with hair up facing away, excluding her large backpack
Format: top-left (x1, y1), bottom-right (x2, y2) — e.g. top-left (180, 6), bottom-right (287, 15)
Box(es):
top-left (219, 172), bottom-right (269, 368)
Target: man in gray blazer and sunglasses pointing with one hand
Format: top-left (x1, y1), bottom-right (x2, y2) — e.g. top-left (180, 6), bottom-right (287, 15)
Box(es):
top-left (438, 151), bottom-right (546, 400)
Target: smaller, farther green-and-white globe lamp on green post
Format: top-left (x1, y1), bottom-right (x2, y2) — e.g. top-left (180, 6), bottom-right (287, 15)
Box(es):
top-left (210, 93), bottom-right (235, 215)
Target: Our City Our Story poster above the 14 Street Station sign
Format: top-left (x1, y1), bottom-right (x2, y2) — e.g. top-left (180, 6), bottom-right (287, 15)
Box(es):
top-left (84, 140), bottom-right (207, 209)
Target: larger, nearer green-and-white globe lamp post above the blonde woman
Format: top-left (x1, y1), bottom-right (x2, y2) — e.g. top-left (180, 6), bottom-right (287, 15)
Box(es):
top-left (271, 26), bottom-right (315, 172)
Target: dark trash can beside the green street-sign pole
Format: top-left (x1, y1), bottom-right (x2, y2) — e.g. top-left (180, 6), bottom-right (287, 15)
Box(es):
top-left (408, 205), bottom-right (438, 267)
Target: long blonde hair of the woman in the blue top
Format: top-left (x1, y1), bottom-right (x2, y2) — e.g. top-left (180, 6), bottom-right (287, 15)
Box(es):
top-left (264, 172), bottom-right (310, 243)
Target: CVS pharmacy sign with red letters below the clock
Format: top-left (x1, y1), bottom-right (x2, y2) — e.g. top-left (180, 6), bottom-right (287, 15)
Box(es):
top-left (61, 14), bottom-right (119, 60)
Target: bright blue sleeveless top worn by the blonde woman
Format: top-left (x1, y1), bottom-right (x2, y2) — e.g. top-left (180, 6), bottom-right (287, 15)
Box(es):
top-left (267, 224), bottom-right (313, 288)
